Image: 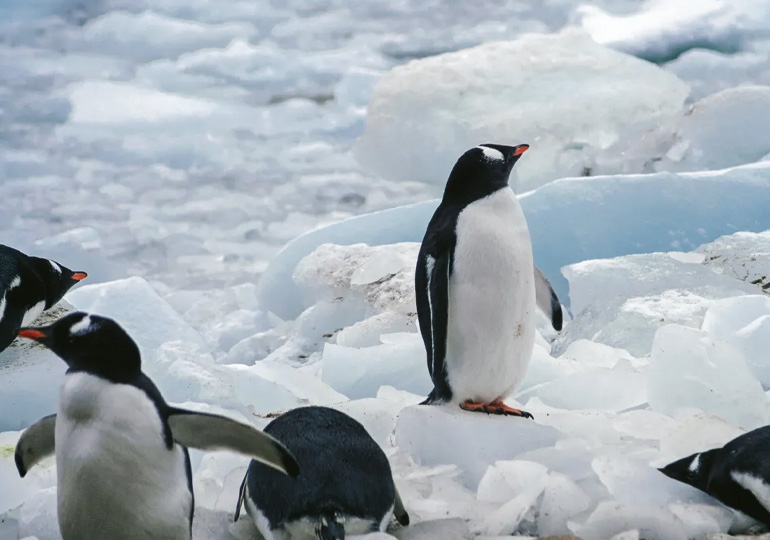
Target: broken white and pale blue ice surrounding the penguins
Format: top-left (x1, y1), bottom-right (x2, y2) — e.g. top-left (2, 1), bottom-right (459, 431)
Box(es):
top-left (0, 0), bottom-right (770, 540)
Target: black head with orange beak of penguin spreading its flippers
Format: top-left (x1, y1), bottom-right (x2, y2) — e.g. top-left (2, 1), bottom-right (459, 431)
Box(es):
top-left (19, 312), bottom-right (142, 382)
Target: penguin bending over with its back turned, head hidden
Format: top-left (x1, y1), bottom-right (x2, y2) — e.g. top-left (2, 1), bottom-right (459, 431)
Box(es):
top-left (235, 407), bottom-right (409, 540)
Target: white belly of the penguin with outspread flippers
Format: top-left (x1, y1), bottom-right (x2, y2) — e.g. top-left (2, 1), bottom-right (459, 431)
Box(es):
top-left (56, 374), bottom-right (192, 540)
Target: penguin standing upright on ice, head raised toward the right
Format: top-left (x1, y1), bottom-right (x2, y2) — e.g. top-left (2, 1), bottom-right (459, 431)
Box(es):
top-left (415, 144), bottom-right (562, 418)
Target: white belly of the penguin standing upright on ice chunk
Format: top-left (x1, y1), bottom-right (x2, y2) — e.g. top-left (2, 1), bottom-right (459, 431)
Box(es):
top-left (446, 188), bottom-right (535, 403)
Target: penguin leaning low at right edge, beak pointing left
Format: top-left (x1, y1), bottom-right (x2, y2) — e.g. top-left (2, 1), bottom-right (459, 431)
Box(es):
top-left (660, 426), bottom-right (770, 526)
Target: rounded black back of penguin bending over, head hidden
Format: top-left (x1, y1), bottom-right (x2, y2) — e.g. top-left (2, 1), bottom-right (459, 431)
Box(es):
top-left (246, 407), bottom-right (395, 529)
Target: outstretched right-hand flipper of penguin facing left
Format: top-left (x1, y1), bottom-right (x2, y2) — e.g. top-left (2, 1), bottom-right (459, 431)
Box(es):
top-left (168, 408), bottom-right (299, 478)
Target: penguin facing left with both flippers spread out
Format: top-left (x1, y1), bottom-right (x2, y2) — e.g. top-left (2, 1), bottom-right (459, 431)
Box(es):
top-left (16, 313), bottom-right (298, 540)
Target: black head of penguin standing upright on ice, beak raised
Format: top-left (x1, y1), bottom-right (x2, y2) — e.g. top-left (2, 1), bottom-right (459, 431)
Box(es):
top-left (444, 143), bottom-right (529, 204)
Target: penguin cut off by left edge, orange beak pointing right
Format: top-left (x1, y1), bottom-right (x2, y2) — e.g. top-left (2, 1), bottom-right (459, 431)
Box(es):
top-left (0, 244), bottom-right (88, 351)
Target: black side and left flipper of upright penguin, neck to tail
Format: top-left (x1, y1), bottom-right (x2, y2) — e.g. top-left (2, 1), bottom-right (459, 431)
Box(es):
top-left (414, 206), bottom-right (457, 403)
